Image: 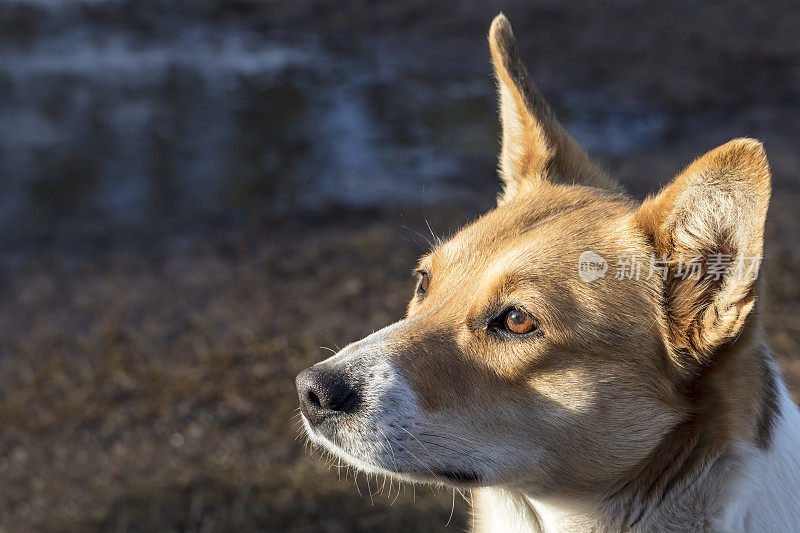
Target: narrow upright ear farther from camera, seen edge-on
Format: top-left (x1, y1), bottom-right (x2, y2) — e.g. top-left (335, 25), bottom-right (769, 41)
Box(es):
top-left (489, 13), bottom-right (616, 204)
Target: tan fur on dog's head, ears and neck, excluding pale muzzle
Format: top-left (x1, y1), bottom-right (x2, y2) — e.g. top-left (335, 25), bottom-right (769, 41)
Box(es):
top-left (388, 16), bottom-right (769, 490)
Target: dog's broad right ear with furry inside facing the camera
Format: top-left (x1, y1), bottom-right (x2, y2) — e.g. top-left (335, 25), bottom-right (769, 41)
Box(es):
top-left (637, 139), bottom-right (770, 363)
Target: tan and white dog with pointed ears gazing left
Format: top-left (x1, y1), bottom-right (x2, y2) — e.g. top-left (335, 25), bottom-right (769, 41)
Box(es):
top-left (296, 14), bottom-right (800, 532)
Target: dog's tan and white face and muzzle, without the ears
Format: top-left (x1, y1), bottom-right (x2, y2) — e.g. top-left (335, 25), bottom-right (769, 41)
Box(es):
top-left (299, 186), bottom-right (676, 492)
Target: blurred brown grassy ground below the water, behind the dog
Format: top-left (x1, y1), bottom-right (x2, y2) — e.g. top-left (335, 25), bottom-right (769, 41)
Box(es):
top-left (0, 194), bottom-right (800, 531)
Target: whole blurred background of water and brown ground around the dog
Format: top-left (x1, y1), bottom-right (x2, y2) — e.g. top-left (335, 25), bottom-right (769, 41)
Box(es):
top-left (0, 0), bottom-right (800, 531)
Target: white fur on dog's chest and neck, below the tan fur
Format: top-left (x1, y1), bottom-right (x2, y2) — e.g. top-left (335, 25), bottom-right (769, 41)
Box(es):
top-left (474, 384), bottom-right (800, 533)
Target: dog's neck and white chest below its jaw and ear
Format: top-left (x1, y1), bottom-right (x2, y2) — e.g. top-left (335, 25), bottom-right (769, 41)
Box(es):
top-left (475, 356), bottom-right (800, 532)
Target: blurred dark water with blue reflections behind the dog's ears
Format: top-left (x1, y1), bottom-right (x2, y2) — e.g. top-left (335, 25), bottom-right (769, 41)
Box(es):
top-left (0, 0), bottom-right (666, 241)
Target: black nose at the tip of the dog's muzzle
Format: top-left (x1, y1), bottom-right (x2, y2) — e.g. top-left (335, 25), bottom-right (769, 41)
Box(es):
top-left (295, 365), bottom-right (359, 424)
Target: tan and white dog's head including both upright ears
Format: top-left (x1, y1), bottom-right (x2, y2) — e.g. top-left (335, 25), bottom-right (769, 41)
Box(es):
top-left (297, 15), bottom-right (770, 493)
